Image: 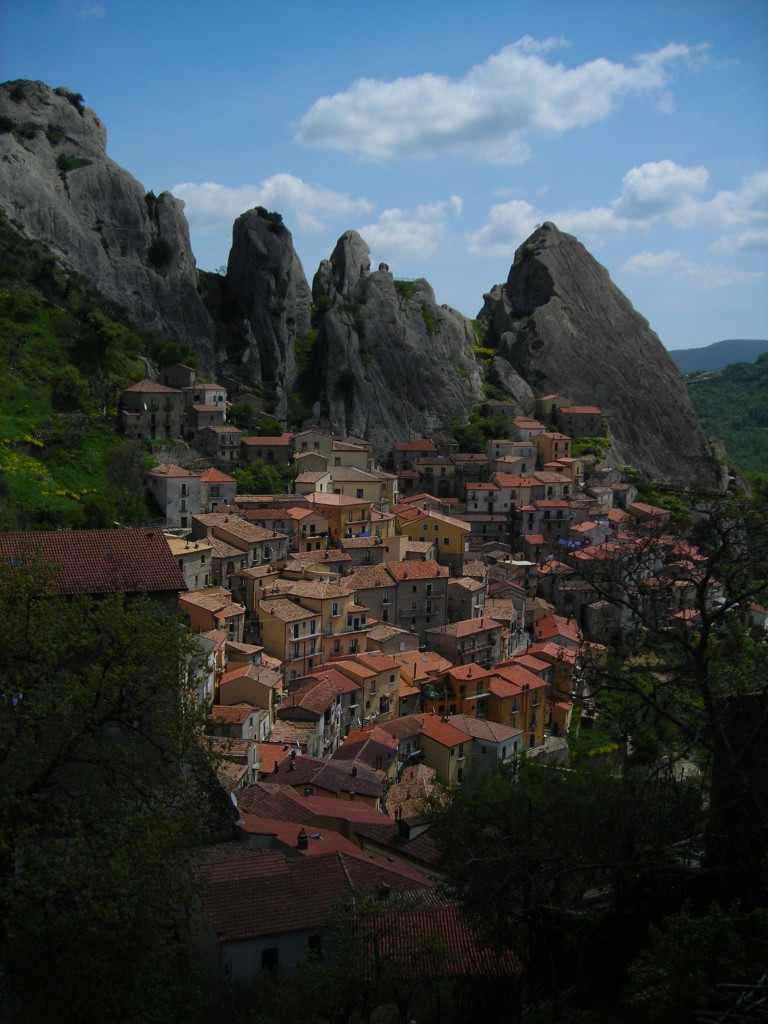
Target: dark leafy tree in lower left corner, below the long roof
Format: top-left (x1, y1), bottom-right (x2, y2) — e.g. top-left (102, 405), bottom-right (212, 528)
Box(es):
top-left (0, 551), bottom-right (217, 1022)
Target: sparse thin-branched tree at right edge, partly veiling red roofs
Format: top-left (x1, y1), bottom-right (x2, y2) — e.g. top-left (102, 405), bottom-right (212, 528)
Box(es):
top-left (583, 496), bottom-right (768, 884)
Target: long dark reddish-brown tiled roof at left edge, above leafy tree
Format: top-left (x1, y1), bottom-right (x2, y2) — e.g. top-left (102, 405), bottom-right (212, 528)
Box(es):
top-left (0, 527), bottom-right (186, 595)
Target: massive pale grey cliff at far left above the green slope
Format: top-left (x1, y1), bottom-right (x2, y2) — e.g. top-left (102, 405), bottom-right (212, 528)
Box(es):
top-left (0, 81), bottom-right (213, 374)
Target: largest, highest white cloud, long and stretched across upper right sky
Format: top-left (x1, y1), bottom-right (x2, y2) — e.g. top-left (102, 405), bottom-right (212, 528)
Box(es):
top-left (296, 36), bottom-right (706, 164)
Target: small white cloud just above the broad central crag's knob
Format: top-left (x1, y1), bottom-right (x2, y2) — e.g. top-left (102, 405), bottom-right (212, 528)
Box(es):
top-left (359, 196), bottom-right (463, 260)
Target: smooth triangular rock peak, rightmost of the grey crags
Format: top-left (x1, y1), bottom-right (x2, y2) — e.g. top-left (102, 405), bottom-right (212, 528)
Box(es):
top-left (478, 223), bottom-right (719, 487)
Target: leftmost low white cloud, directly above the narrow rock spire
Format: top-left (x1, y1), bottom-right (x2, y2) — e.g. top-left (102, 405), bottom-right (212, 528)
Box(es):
top-left (171, 174), bottom-right (373, 234)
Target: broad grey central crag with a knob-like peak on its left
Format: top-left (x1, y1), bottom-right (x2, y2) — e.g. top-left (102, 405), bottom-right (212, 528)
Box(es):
top-left (312, 231), bottom-right (482, 455)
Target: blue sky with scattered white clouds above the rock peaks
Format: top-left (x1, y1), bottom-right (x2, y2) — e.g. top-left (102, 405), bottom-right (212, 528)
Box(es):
top-left (0, 0), bottom-right (768, 349)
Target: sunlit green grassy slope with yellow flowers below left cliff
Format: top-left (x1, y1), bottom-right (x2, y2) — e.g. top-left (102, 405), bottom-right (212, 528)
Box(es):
top-left (0, 208), bottom-right (195, 529)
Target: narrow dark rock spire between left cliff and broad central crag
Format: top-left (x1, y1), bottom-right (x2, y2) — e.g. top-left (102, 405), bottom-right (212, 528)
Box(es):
top-left (219, 207), bottom-right (312, 417)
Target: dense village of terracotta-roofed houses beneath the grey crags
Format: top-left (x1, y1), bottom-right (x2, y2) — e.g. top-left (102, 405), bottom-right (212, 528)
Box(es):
top-left (2, 354), bottom-right (768, 981)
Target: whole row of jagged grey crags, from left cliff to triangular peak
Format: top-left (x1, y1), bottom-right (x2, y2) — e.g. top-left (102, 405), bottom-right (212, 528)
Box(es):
top-left (0, 82), bottom-right (720, 487)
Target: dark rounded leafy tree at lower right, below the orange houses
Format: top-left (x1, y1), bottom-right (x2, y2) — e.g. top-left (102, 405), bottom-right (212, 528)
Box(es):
top-left (431, 761), bottom-right (699, 1012)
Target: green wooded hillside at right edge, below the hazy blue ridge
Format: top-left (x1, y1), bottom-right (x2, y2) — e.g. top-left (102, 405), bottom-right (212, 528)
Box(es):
top-left (686, 354), bottom-right (768, 473)
